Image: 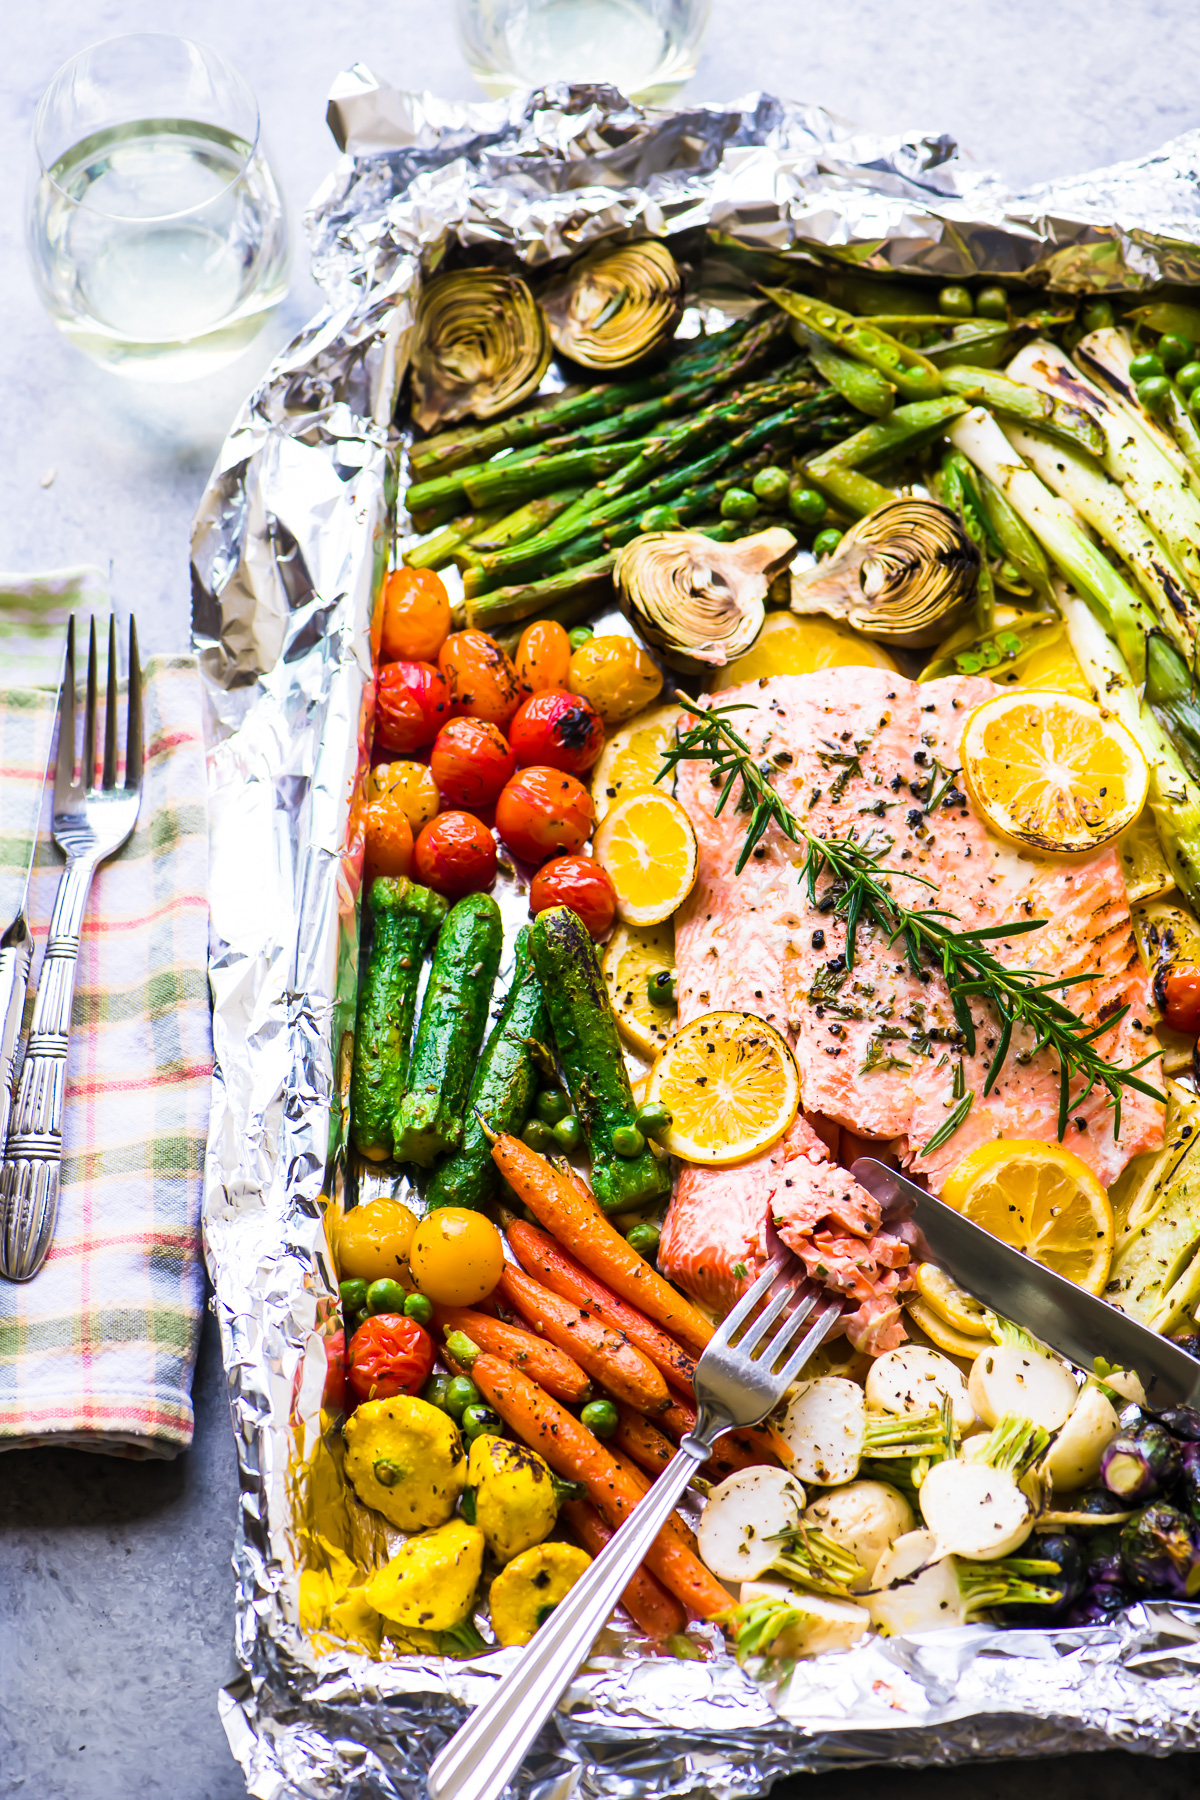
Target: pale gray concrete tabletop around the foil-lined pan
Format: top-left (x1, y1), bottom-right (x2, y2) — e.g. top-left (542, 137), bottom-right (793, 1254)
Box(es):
top-left (0, 0), bottom-right (1200, 1800)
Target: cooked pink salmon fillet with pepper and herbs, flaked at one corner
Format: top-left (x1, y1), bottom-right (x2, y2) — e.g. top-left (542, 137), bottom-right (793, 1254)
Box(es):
top-left (660, 668), bottom-right (1162, 1348)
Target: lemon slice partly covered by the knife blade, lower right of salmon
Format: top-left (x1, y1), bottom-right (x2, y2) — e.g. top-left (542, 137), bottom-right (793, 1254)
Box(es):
top-left (941, 1138), bottom-right (1114, 1294)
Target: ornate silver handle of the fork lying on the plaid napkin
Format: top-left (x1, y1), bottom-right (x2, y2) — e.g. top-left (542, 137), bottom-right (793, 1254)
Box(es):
top-left (0, 855), bottom-right (97, 1282)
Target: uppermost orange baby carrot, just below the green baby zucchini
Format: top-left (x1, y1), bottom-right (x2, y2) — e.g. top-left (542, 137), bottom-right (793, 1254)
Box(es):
top-left (491, 1136), bottom-right (716, 1350)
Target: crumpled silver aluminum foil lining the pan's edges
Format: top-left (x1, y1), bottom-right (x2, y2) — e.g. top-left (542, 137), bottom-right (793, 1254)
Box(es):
top-left (193, 67), bottom-right (1200, 1800)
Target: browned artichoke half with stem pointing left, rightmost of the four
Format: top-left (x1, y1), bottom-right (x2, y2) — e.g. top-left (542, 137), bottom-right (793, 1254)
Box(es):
top-left (792, 499), bottom-right (979, 650)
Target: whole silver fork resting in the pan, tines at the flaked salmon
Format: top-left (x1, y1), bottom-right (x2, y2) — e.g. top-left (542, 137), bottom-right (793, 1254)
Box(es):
top-left (426, 1256), bottom-right (842, 1800)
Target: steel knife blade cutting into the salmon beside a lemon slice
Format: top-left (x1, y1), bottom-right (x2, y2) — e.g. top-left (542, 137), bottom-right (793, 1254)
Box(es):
top-left (851, 1156), bottom-right (1200, 1408)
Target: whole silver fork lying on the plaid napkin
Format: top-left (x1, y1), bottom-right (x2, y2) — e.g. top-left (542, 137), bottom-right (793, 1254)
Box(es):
top-left (0, 616), bottom-right (142, 1282)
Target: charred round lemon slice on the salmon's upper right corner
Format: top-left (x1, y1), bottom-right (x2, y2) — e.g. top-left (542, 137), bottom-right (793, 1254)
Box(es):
top-left (963, 689), bottom-right (1150, 857)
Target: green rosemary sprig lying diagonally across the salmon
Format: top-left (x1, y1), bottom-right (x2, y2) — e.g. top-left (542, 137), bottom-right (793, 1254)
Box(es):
top-left (655, 695), bottom-right (1162, 1150)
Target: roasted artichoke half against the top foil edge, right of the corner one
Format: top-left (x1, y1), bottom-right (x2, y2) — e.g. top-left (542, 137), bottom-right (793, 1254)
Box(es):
top-left (542, 238), bottom-right (684, 369)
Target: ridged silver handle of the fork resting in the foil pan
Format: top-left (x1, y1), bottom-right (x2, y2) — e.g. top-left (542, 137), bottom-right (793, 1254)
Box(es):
top-left (426, 1415), bottom-right (723, 1800)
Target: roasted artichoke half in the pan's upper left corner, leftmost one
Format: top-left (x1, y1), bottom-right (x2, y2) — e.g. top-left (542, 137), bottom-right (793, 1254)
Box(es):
top-left (412, 268), bottom-right (551, 430)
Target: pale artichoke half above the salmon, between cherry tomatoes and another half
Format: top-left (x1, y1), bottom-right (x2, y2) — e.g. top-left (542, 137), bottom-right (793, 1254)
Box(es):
top-left (613, 526), bottom-right (795, 675)
